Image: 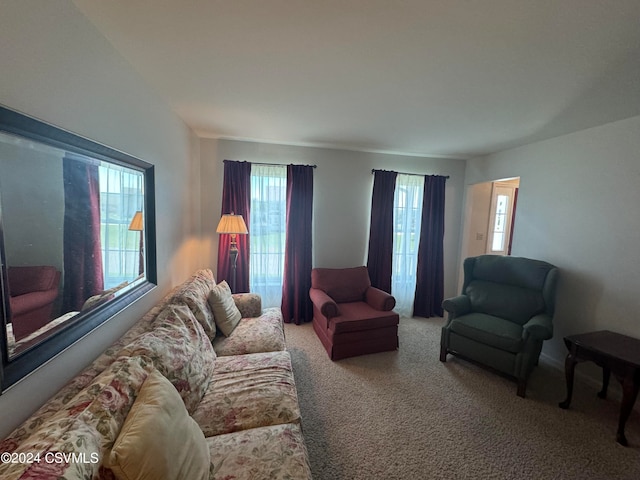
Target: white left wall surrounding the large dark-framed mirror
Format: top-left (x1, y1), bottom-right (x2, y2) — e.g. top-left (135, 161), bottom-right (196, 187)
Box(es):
top-left (0, 0), bottom-right (200, 438)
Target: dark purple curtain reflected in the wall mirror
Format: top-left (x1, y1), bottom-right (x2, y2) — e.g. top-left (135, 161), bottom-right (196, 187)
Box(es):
top-left (62, 153), bottom-right (104, 312)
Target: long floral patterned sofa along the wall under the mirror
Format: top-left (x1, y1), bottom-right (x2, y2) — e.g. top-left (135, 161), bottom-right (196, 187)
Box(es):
top-left (0, 270), bottom-right (311, 480)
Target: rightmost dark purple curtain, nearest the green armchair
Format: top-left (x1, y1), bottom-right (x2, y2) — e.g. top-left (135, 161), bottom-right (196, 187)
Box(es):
top-left (413, 175), bottom-right (447, 317)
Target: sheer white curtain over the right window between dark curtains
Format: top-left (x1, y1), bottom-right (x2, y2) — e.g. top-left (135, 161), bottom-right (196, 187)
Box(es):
top-left (391, 173), bottom-right (424, 317)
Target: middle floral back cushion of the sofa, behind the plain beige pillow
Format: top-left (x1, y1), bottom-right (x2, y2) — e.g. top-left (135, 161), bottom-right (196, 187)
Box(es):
top-left (115, 304), bottom-right (216, 414)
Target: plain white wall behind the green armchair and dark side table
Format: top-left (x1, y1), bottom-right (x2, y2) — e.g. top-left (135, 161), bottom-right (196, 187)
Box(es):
top-left (466, 117), bottom-right (640, 374)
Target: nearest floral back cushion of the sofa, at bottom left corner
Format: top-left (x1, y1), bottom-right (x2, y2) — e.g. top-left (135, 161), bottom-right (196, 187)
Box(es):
top-left (0, 357), bottom-right (153, 480)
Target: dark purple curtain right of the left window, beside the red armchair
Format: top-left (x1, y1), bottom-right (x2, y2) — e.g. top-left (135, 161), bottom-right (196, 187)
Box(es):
top-left (281, 165), bottom-right (313, 324)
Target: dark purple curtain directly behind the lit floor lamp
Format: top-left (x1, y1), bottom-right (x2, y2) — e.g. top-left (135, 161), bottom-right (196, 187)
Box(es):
top-left (216, 160), bottom-right (251, 293)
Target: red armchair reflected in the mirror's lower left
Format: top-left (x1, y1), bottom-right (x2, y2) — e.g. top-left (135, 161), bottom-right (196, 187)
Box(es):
top-left (7, 266), bottom-right (60, 340)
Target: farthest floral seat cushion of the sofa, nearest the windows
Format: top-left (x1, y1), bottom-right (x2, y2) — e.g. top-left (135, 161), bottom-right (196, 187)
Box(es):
top-left (213, 307), bottom-right (286, 356)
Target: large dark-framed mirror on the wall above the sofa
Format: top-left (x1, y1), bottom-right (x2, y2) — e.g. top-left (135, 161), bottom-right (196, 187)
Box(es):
top-left (0, 107), bottom-right (157, 391)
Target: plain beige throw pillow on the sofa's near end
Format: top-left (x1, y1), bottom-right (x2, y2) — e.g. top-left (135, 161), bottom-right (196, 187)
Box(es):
top-left (108, 371), bottom-right (211, 480)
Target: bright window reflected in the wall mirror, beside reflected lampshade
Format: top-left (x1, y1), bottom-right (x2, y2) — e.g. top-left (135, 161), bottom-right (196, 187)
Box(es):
top-left (99, 163), bottom-right (144, 289)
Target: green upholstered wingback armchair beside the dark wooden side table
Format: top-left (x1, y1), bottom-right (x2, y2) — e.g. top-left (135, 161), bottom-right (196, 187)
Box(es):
top-left (440, 255), bottom-right (558, 397)
